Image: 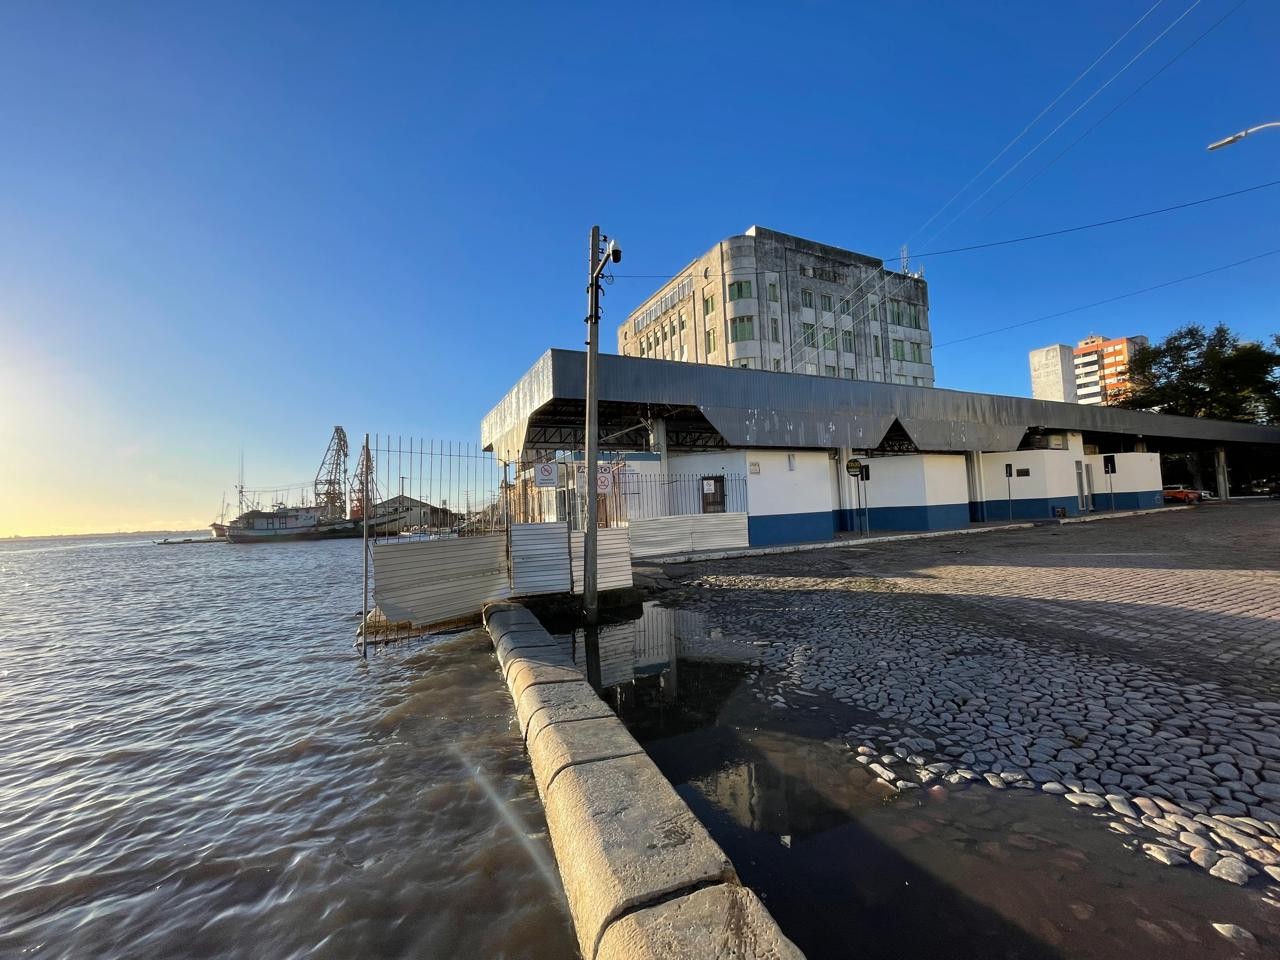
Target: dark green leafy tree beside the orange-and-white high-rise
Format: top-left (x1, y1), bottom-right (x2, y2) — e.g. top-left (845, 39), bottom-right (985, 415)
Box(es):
top-left (1112, 324), bottom-right (1280, 424)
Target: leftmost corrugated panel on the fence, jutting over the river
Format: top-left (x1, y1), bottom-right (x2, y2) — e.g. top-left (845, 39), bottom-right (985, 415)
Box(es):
top-left (372, 534), bottom-right (511, 626)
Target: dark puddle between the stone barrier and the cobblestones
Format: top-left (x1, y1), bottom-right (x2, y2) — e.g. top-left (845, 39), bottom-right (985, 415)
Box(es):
top-left (561, 603), bottom-right (1280, 960)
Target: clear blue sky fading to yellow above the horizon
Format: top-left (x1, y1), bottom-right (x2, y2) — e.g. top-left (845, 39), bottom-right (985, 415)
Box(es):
top-left (0, 0), bottom-right (1280, 535)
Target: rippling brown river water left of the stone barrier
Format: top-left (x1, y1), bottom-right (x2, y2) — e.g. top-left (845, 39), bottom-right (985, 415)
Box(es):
top-left (0, 536), bottom-right (576, 960)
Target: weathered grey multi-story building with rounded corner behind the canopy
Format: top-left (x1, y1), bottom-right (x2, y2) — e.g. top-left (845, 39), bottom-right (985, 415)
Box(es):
top-left (618, 227), bottom-right (933, 387)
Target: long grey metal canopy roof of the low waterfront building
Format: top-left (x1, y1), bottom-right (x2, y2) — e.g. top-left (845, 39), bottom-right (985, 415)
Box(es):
top-left (480, 349), bottom-right (1280, 460)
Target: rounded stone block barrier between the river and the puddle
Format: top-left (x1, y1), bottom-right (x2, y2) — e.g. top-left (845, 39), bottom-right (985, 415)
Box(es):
top-left (484, 603), bottom-right (804, 960)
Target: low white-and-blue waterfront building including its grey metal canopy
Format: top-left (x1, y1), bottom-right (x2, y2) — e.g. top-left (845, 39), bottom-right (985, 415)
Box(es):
top-left (481, 351), bottom-right (1280, 548)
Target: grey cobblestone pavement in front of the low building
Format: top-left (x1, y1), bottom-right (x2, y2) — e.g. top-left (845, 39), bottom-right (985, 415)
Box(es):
top-left (666, 502), bottom-right (1280, 902)
